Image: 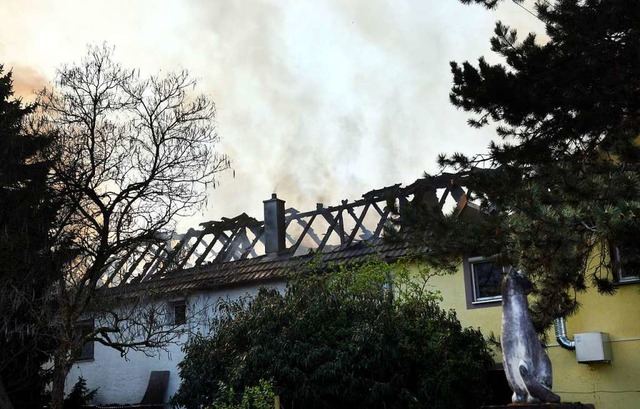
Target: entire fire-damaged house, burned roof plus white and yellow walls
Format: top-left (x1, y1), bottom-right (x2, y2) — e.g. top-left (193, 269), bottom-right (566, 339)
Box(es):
top-left (67, 175), bottom-right (640, 409)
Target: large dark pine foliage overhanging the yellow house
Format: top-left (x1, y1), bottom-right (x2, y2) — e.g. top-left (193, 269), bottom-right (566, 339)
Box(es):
top-left (402, 0), bottom-right (640, 330)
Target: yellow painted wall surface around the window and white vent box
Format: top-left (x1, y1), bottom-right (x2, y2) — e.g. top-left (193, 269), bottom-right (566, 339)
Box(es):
top-left (429, 267), bottom-right (640, 409)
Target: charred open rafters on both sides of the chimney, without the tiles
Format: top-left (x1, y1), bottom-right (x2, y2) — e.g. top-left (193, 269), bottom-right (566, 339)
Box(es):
top-left (100, 174), bottom-right (469, 285)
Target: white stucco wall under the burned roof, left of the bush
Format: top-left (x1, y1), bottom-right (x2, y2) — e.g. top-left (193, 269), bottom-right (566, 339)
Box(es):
top-left (66, 283), bottom-right (285, 404)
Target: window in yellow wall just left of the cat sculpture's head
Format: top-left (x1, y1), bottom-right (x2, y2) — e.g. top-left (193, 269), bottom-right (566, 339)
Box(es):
top-left (464, 253), bottom-right (504, 308)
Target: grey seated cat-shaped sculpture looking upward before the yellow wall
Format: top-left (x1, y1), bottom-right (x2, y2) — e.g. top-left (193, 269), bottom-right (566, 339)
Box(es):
top-left (500, 271), bottom-right (560, 403)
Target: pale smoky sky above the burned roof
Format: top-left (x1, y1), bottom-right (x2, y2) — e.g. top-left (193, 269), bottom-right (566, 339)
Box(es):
top-left (0, 0), bottom-right (541, 229)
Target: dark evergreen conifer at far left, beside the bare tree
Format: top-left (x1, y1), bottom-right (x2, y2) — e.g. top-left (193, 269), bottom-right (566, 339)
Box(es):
top-left (0, 65), bottom-right (56, 408)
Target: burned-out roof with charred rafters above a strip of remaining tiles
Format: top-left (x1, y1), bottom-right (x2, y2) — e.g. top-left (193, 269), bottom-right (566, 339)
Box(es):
top-left (100, 178), bottom-right (456, 292)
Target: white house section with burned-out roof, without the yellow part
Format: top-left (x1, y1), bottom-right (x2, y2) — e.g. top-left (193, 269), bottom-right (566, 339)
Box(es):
top-left (66, 185), bottom-right (415, 404)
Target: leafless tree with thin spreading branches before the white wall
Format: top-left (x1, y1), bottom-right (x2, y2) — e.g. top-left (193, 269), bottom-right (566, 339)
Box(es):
top-left (39, 46), bottom-right (229, 409)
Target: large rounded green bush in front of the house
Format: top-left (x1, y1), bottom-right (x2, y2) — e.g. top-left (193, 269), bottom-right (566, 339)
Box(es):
top-left (173, 260), bottom-right (492, 409)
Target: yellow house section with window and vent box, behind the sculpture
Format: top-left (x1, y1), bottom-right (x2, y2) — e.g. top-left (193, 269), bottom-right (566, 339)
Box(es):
top-left (433, 256), bottom-right (640, 409)
